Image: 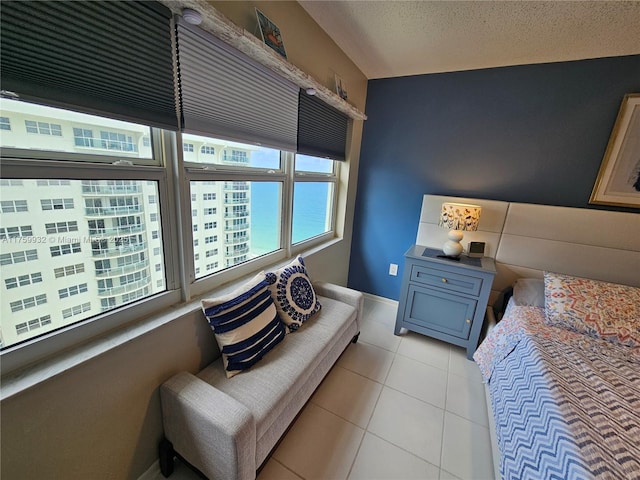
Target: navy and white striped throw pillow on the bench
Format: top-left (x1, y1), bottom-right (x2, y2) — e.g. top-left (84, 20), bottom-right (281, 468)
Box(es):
top-left (202, 272), bottom-right (286, 378)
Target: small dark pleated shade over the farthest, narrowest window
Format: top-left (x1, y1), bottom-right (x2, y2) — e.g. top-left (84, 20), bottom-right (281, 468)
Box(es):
top-left (297, 90), bottom-right (349, 160)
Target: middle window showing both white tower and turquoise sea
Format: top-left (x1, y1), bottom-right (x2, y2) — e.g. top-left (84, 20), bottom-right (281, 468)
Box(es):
top-left (182, 134), bottom-right (286, 288)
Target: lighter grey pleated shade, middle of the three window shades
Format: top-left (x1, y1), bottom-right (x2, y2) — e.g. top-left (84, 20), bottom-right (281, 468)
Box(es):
top-left (177, 18), bottom-right (298, 151)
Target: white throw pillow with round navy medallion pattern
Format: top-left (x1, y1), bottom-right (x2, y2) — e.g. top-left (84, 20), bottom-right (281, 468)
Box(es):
top-left (267, 256), bottom-right (322, 332)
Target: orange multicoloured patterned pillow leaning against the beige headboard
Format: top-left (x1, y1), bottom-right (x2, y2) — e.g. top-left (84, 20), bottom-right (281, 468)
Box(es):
top-left (544, 272), bottom-right (640, 347)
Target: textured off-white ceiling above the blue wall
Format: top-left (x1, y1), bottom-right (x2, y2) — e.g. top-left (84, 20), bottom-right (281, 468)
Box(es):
top-left (299, 0), bottom-right (640, 78)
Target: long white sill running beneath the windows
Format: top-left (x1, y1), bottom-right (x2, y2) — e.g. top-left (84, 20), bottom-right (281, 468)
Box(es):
top-left (0, 238), bottom-right (341, 401)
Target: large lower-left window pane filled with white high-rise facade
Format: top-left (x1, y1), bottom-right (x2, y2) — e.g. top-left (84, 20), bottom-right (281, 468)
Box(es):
top-left (0, 174), bottom-right (170, 347)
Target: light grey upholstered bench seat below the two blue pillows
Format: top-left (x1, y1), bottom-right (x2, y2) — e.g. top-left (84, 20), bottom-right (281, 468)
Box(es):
top-left (197, 297), bottom-right (357, 439)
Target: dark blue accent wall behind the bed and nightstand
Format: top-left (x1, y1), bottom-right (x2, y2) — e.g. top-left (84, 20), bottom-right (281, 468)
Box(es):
top-left (349, 55), bottom-right (640, 300)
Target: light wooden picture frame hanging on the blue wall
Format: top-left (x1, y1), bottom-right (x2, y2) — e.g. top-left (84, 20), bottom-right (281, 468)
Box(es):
top-left (589, 93), bottom-right (640, 208)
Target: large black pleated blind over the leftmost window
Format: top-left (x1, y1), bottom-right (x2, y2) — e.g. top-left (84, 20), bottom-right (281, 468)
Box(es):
top-left (0, 1), bottom-right (178, 130)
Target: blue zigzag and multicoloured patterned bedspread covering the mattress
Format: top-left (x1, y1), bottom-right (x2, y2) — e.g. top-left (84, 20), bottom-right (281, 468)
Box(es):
top-left (474, 303), bottom-right (640, 480)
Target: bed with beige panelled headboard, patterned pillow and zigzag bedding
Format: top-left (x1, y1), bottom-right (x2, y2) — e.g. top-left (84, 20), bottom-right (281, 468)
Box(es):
top-left (416, 195), bottom-right (640, 480)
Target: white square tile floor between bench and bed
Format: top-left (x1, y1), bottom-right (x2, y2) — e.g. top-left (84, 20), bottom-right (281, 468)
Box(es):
top-left (159, 296), bottom-right (493, 480)
